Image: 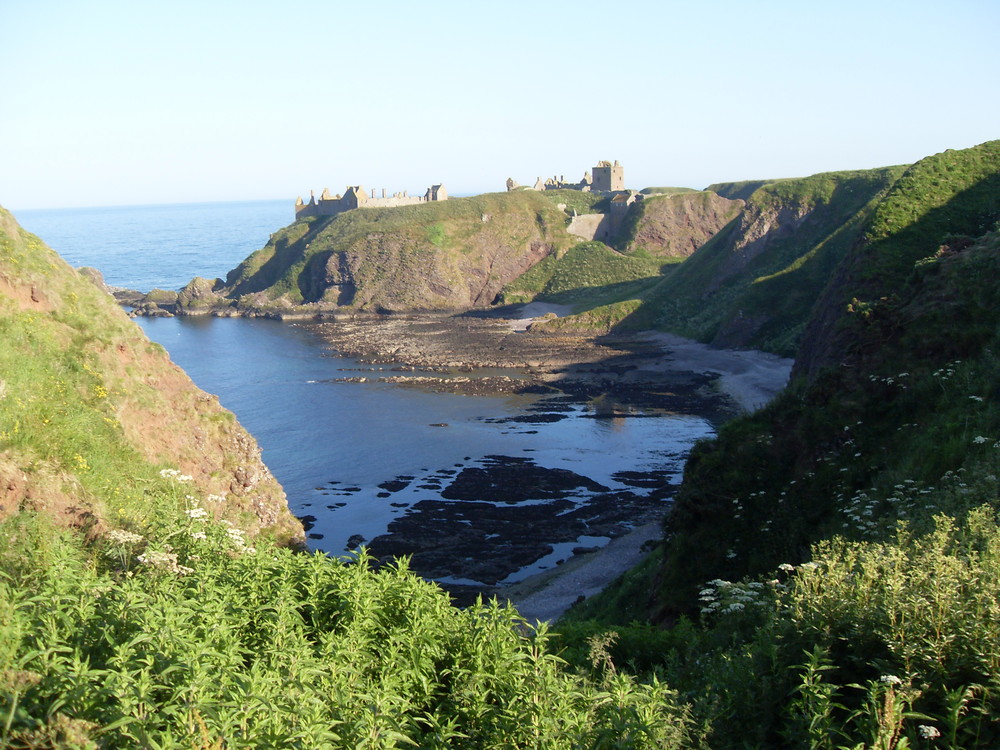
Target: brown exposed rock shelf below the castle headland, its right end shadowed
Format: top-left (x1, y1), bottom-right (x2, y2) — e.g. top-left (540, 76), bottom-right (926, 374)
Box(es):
top-left (300, 308), bottom-right (738, 420)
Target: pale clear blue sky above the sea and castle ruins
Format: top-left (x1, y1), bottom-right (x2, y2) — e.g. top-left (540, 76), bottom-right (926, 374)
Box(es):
top-left (0, 0), bottom-right (1000, 210)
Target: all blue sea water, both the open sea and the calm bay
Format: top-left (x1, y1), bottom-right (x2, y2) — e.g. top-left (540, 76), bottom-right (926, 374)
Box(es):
top-left (16, 200), bottom-right (713, 583)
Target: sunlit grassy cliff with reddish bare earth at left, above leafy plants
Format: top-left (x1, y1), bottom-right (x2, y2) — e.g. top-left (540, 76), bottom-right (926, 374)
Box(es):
top-left (0, 209), bottom-right (302, 542)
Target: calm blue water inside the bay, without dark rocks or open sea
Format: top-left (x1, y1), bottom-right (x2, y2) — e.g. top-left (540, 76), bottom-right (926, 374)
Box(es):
top-left (138, 318), bottom-right (711, 580)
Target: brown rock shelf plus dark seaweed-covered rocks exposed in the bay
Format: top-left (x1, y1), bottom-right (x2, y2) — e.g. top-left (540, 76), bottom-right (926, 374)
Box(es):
top-left (292, 307), bottom-right (790, 619)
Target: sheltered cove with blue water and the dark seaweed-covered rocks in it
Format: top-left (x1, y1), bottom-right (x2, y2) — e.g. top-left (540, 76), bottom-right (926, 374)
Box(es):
top-left (137, 317), bottom-right (713, 586)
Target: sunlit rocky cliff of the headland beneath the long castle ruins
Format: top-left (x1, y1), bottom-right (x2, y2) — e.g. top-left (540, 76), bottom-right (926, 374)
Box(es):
top-left (218, 191), bottom-right (573, 312)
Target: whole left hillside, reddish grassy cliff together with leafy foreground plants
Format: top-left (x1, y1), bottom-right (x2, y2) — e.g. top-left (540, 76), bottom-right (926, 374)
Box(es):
top-left (0, 204), bottom-right (692, 750)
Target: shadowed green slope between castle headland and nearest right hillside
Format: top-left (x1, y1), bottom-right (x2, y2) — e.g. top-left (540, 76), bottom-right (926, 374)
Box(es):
top-left (625, 168), bottom-right (903, 356)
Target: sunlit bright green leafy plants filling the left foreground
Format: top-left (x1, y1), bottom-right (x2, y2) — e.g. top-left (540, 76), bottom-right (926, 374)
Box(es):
top-left (0, 484), bottom-right (691, 748)
